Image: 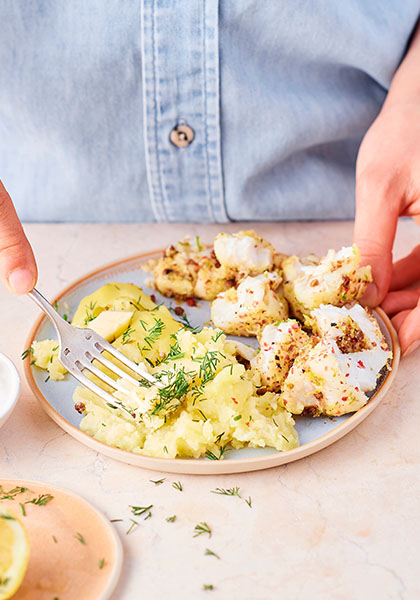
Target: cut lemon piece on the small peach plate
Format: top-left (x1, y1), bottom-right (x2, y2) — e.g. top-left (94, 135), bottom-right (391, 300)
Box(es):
top-left (0, 508), bottom-right (29, 600)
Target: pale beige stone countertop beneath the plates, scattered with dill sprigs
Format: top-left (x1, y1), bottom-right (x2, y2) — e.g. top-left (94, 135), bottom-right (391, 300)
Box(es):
top-left (0, 220), bottom-right (420, 600)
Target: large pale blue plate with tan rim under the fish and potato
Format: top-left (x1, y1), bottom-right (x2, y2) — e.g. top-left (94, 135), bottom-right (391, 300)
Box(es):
top-left (25, 252), bottom-right (400, 474)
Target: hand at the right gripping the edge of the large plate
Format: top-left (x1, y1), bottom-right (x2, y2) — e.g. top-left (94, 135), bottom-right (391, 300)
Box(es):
top-left (354, 102), bottom-right (420, 355)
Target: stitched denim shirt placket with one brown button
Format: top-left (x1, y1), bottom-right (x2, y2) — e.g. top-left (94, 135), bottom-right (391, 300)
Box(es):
top-left (142, 0), bottom-right (228, 222)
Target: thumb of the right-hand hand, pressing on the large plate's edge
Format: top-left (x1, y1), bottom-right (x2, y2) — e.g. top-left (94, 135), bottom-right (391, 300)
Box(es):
top-left (353, 173), bottom-right (399, 306)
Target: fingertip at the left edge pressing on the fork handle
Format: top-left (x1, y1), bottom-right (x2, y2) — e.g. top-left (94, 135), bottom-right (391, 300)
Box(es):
top-left (0, 181), bottom-right (37, 294)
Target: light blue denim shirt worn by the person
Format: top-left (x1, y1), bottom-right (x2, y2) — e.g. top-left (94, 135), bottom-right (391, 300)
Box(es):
top-left (0, 0), bottom-right (420, 222)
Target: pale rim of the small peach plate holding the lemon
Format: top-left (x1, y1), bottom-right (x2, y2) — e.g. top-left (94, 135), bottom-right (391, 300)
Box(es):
top-left (0, 477), bottom-right (124, 600)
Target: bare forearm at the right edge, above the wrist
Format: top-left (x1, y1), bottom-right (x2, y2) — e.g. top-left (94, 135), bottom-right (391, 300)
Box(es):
top-left (384, 21), bottom-right (420, 109)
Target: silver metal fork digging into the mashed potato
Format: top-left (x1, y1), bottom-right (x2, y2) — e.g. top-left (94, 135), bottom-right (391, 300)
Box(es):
top-left (28, 288), bottom-right (163, 408)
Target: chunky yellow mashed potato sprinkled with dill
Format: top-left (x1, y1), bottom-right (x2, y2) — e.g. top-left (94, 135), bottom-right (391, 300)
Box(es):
top-left (34, 284), bottom-right (299, 458)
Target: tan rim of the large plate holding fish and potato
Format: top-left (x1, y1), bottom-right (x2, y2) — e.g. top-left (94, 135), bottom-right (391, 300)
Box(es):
top-left (24, 249), bottom-right (400, 475)
